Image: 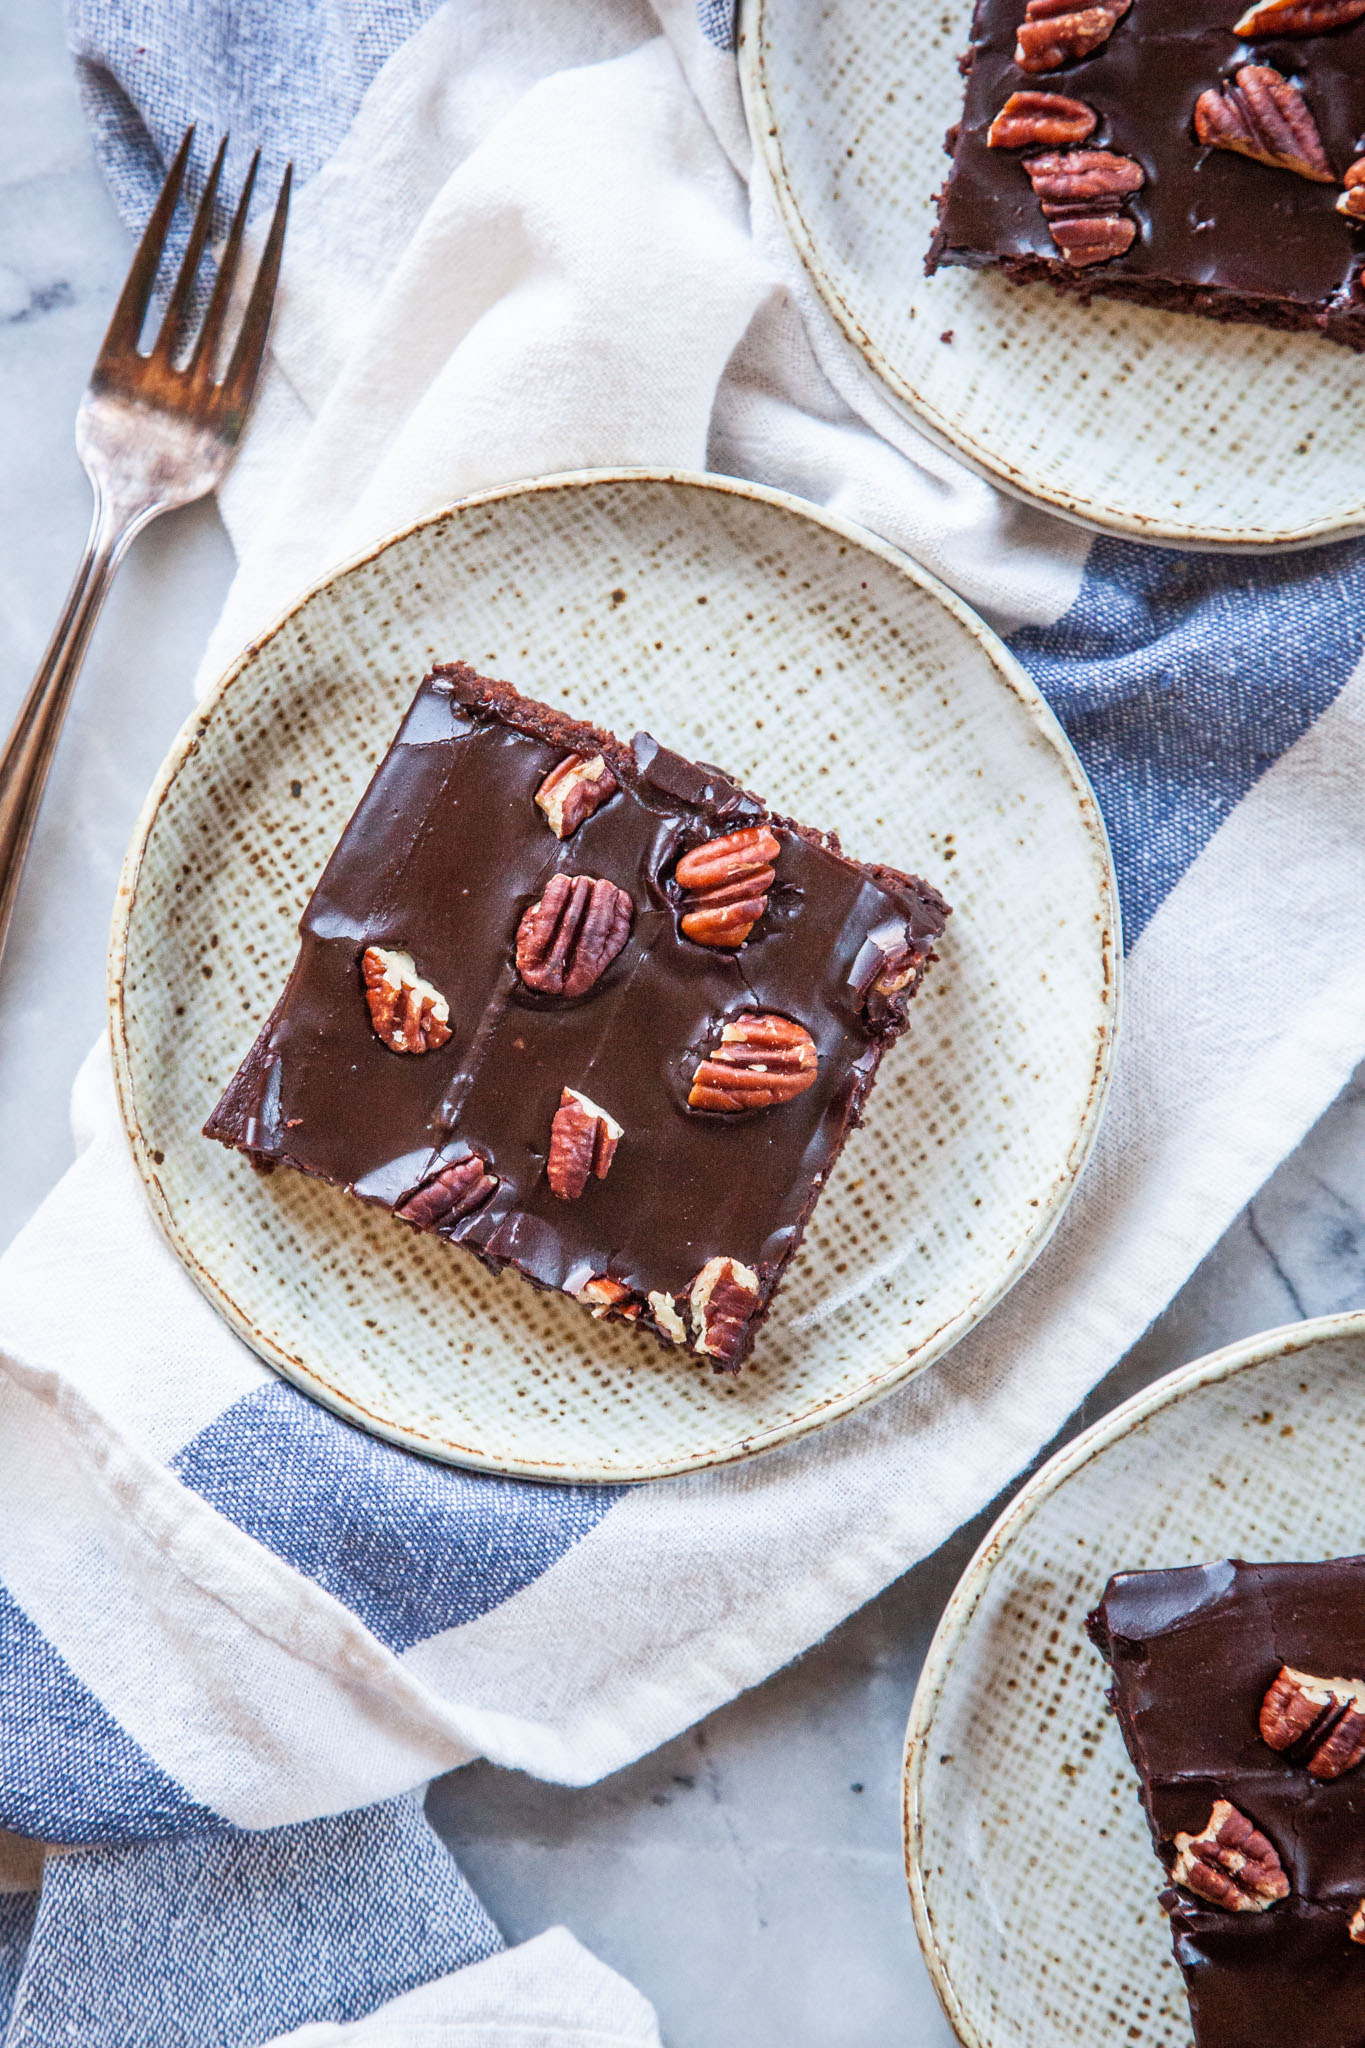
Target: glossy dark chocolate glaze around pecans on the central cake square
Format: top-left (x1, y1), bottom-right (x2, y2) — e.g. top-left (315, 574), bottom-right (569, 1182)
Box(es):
top-left (205, 666), bottom-right (948, 1356)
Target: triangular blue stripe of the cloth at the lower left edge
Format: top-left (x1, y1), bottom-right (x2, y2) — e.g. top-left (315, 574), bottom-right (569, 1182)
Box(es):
top-left (0, 1585), bottom-right (227, 1841)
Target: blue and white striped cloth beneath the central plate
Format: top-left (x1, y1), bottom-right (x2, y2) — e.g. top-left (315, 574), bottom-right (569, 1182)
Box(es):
top-left (0, 0), bottom-right (1365, 2048)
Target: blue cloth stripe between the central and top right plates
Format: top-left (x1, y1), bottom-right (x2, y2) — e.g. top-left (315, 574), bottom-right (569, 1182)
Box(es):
top-left (1009, 539), bottom-right (1365, 946)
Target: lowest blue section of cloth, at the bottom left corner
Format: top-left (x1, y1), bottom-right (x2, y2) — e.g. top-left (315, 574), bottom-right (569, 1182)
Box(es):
top-left (4, 1792), bottom-right (501, 2048)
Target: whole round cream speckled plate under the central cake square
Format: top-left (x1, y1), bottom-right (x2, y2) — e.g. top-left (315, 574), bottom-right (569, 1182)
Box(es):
top-left (113, 473), bottom-right (1115, 1479)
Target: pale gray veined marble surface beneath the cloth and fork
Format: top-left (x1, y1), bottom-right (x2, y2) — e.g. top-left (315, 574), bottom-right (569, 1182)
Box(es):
top-left (0, 0), bottom-right (1365, 2048)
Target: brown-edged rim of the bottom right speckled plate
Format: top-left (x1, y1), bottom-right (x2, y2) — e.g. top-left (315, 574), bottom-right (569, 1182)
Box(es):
top-left (900, 1309), bottom-right (1365, 2048)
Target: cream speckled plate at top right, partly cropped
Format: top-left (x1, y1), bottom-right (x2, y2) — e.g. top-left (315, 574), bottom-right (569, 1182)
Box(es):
top-left (741, 0), bottom-right (1365, 547)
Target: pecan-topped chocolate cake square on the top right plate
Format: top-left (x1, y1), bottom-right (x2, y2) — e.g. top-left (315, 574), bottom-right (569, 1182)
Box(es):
top-left (927, 0), bottom-right (1365, 348)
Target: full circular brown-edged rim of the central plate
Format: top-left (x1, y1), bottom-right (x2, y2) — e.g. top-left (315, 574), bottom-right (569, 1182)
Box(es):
top-left (106, 465), bottom-right (1124, 1485)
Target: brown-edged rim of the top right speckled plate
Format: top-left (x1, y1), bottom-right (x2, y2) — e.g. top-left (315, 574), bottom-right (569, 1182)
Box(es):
top-left (735, 0), bottom-right (1365, 555)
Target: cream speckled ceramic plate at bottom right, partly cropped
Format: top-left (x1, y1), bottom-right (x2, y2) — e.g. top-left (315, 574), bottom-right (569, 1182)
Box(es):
top-left (905, 1315), bottom-right (1365, 2048)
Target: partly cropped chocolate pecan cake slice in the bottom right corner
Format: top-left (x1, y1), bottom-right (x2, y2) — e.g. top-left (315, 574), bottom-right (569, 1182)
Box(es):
top-left (1089, 1556), bottom-right (1365, 2048)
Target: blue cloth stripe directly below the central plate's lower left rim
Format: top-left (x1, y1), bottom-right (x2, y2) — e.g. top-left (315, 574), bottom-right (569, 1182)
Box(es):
top-left (174, 1382), bottom-right (628, 1651)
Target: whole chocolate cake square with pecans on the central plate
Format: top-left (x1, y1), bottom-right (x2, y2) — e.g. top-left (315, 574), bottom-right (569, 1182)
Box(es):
top-left (205, 664), bottom-right (948, 1370)
